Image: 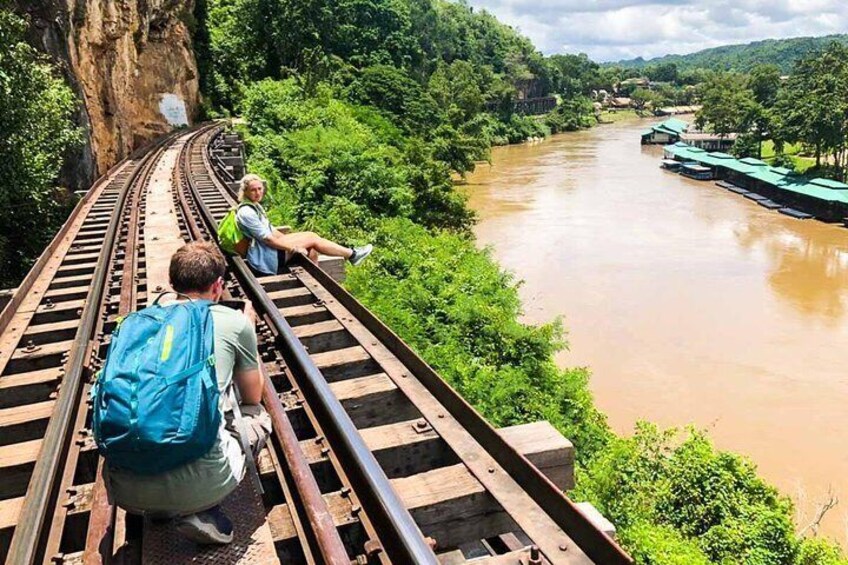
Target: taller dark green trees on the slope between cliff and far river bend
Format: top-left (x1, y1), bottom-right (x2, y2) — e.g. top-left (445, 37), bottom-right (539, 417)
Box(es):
top-left (195, 0), bottom-right (597, 150)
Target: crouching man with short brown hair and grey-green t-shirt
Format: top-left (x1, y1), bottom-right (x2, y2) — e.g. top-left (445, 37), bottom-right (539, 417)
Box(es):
top-left (95, 242), bottom-right (271, 543)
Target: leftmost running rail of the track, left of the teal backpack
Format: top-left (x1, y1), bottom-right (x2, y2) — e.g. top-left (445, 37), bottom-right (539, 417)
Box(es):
top-left (6, 136), bottom-right (177, 565)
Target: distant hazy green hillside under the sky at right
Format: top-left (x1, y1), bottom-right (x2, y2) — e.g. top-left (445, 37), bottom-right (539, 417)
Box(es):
top-left (607, 34), bottom-right (848, 74)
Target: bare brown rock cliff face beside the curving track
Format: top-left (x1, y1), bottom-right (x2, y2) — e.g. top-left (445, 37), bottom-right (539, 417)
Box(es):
top-left (19, 0), bottom-right (199, 184)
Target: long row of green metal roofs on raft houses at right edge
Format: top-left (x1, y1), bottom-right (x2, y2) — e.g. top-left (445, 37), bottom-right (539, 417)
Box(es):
top-left (663, 141), bottom-right (848, 204)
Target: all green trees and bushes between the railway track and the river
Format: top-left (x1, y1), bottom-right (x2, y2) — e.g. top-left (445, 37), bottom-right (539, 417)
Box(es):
top-left (198, 0), bottom-right (842, 565)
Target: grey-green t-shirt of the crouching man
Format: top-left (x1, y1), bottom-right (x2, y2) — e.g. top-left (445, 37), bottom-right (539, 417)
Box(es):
top-left (106, 304), bottom-right (258, 514)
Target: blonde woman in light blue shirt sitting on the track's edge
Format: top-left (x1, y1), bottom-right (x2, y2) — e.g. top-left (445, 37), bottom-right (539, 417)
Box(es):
top-left (236, 175), bottom-right (373, 275)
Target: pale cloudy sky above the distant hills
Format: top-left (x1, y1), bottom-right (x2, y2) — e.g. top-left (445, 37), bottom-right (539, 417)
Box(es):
top-left (468, 0), bottom-right (848, 62)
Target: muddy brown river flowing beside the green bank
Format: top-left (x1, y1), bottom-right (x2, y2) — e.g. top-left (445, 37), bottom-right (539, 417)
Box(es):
top-left (467, 119), bottom-right (848, 544)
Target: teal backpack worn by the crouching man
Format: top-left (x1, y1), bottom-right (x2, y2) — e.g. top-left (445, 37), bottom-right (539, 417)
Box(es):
top-left (92, 295), bottom-right (221, 475)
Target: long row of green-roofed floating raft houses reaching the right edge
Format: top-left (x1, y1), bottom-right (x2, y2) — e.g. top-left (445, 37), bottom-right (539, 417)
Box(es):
top-left (663, 141), bottom-right (848, 222)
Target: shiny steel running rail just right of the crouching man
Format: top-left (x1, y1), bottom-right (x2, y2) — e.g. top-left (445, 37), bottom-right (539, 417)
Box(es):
top-left (184, 130), bottom-right (438, 565)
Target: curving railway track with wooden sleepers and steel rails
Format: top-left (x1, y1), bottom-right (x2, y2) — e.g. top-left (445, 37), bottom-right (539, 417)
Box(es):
top-left (0, 125), bottom-right (630, 564)
